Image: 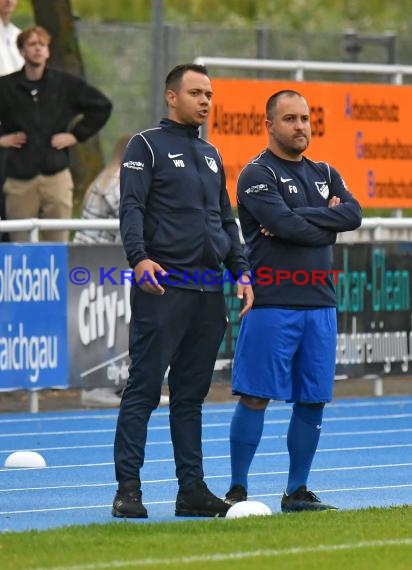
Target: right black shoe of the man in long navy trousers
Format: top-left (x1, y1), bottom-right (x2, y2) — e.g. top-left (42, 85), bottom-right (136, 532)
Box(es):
top-left (175, 481), bottom-right (230, 517)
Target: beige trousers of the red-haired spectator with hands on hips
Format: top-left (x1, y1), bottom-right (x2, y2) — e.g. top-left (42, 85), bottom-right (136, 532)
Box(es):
top-left (3, 168), bottom-right (73, 242)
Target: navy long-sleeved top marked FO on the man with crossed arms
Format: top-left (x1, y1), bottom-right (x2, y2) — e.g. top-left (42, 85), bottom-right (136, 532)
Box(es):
top-left (237, 149), bottom-right (361, 308)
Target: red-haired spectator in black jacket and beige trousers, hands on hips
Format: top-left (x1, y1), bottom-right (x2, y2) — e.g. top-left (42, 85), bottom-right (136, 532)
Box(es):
top-left (0, 26), bottom-right (112, 242)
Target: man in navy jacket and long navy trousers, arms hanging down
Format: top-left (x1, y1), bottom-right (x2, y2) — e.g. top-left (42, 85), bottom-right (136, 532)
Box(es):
top-left (112, 64), bottom-right (253, 518)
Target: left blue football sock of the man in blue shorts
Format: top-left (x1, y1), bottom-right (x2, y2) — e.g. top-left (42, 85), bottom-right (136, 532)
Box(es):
top-left (230, 402), bottom-right (265, 490)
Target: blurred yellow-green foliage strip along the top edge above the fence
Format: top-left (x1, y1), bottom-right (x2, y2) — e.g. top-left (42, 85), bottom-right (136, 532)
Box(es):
top-left (17, 0), bottom-right (412, 35)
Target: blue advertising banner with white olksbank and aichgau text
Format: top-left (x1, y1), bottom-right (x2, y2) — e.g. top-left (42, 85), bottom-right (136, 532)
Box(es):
top-left (0, 250), bottom-right (65, 387)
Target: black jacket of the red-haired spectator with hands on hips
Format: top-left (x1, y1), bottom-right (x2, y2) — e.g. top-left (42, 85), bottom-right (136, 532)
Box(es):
top-left (0, 67), bottom-right (112, 175)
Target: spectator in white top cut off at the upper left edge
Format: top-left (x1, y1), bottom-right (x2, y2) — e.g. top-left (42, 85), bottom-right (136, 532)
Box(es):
top-left (0, 0), bottom-right (24, 242)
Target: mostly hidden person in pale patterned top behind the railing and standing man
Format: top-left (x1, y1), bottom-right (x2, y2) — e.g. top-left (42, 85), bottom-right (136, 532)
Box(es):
top-left (73, 134), bottom-right (169, 407)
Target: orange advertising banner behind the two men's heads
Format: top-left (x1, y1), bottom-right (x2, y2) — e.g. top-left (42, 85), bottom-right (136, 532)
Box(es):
top-left (207, 78), bottom-right (412, 208)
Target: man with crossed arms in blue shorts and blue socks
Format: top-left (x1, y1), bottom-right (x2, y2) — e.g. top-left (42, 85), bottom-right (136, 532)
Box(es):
top-left (226, 90), bottom-right (361, 512)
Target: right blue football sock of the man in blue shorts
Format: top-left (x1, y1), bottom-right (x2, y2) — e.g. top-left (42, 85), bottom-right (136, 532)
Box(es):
top-left (286, 403), bottom-right (323, 495)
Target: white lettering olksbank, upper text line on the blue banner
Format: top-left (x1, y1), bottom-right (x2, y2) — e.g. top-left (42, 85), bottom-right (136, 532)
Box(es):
top-left (0, 255), bottom-right (60, 303)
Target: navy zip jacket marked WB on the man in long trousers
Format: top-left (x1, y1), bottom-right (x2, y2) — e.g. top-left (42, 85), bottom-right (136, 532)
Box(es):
top-left (120, 119), bottom-right (249, 291)
